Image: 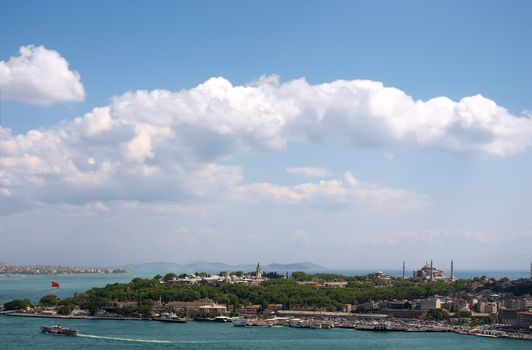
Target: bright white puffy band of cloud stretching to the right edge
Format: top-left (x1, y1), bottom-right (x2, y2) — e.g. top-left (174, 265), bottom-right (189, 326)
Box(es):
top-left (112, 78), bottom-right (532, 157)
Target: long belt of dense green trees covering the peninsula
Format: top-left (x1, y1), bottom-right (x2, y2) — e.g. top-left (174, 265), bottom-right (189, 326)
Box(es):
top-left (43, 273), bottom-right (467, 312)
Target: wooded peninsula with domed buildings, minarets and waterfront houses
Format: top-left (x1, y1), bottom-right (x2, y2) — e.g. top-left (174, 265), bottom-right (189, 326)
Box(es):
top-left (2, 263), bottom-right (532, 339)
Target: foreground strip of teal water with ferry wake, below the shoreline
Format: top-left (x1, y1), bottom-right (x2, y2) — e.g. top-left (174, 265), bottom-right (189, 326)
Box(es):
top-left (0, 316), bottom-right (531, 350)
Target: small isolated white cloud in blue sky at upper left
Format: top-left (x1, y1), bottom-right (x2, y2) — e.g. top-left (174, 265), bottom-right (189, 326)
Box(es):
top-left (0, 45), bottom-right (85, 105)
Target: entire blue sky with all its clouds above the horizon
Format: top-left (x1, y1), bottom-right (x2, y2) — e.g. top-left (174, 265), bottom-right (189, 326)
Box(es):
top-left (0, 0), bottom-right (532, 270)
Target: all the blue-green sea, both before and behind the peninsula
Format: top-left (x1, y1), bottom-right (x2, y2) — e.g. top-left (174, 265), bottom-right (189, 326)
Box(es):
top-left (0, 271), bottom-right (532, 350)
